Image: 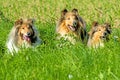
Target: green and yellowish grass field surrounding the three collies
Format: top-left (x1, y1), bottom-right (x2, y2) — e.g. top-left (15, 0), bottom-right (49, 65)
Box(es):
top-left (0, 0), bottom-right (120, 80)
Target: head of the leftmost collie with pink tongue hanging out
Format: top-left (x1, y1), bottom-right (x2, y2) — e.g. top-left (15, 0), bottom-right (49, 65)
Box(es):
top-left (14, 19), bottom-right (35, 42)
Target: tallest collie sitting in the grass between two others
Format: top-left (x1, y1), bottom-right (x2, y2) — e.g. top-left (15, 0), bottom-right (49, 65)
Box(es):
top-left (56, 9), bottom-right (86, 44)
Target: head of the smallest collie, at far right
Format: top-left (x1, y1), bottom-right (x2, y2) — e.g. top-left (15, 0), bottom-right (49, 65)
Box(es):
top-left (89, 22), bottom-right (111, 39)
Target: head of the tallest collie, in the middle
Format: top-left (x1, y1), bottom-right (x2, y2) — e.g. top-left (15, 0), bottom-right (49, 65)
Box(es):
top-left (61, 9), bottom-right (79, 31)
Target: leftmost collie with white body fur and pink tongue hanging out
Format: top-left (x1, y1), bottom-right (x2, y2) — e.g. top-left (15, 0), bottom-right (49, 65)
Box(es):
top-left (6, 19), bottom-right (41, 53)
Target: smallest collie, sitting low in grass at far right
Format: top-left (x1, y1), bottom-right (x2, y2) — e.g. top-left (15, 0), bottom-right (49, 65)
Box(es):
top-left (87, 22), bottom-right (111, 48)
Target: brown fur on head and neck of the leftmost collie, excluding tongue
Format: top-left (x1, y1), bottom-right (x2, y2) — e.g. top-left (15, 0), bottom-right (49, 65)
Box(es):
top-left (15, 19), bottom-right (35, 45)
